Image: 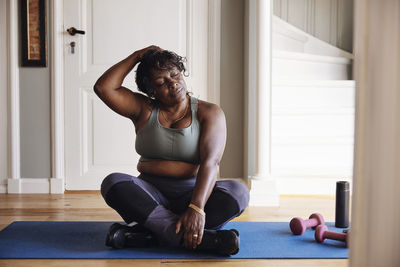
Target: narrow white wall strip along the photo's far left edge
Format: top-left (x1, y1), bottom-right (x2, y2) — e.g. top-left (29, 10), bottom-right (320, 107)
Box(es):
top-left (0, 0), bottom-right (9, 193)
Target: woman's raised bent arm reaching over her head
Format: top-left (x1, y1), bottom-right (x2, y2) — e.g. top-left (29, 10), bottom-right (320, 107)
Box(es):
top-left (94, 46), bottom-right (160, 121)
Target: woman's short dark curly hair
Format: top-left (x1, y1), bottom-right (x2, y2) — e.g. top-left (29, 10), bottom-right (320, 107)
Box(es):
top-left (135, 49), bottom-right (186, 98)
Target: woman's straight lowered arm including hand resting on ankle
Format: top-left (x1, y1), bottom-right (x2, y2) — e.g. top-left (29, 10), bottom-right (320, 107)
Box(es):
top-left (176, 102), bottom-right (226, 249)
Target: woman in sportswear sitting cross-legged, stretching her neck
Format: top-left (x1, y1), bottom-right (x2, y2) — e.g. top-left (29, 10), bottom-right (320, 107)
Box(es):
top-left (94, 46), bottom-right (249, 255)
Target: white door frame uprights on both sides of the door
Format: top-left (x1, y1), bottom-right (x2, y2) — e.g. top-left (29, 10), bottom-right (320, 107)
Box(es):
top-left (50, 0), bottom-right (221, 193)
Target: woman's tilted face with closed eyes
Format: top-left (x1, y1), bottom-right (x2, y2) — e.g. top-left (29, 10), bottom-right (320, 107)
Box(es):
top-left (151, 66), bottom-right (186, 105)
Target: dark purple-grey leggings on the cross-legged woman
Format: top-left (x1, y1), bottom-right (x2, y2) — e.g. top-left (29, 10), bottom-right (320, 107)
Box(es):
top-left (101, 173), bottom-right (249, 245)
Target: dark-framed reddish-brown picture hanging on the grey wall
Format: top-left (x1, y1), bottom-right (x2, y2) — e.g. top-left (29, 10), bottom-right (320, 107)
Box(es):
top-left (20, 0), bottom-right (47, 67)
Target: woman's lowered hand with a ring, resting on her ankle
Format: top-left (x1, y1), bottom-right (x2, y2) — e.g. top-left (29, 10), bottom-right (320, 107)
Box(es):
top-left (176, 208), bottom-right (206, 249)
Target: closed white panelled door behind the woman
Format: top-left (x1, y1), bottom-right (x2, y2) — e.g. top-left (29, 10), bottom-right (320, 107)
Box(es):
top-left (64, 0), bottom-right (208, 190)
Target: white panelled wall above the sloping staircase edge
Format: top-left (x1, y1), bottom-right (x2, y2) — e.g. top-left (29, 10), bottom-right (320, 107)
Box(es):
top-left (274, 0), bottom-right (353, 52)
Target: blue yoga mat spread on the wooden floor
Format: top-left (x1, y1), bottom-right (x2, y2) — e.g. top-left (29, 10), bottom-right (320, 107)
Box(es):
top-left (0, 221), bottom-right (348, 259)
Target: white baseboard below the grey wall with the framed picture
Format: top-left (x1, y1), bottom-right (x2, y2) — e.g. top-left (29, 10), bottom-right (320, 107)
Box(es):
top-left (6, 178), bottom-right (64, 194)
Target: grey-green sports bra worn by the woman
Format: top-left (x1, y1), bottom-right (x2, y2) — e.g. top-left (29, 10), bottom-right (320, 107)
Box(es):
top-left (135, 97), bottom-right (200, 164)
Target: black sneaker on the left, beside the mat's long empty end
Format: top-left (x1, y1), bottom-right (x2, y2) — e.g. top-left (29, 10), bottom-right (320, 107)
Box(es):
top-left (106, 223), bottom-right (158, 249)
